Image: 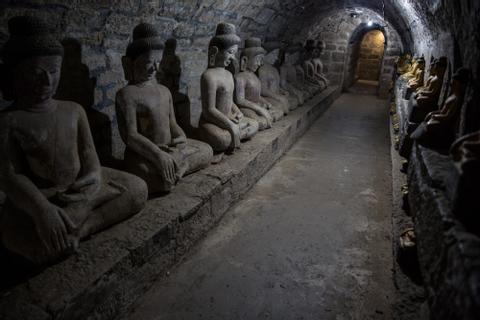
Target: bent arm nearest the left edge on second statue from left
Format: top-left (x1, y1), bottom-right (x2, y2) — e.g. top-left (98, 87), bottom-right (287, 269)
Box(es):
top-left (117, 93), bottom-right (164, 164)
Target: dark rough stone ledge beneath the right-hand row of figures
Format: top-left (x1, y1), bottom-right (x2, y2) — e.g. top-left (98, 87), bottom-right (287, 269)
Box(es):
top-left (408, 144), bottom-right (480, 320)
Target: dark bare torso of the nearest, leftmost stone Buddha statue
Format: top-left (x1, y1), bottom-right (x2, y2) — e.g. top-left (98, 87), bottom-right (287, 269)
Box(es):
top-left (5, 101), bottom-right (84, 188)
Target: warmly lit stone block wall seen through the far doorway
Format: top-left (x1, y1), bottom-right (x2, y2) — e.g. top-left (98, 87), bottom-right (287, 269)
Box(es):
top-left (356, 30), bottom-right (385, 81)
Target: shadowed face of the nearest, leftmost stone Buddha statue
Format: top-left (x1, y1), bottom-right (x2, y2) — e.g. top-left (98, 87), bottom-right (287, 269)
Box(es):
top-left (13, 56), bottom-right (62, 103)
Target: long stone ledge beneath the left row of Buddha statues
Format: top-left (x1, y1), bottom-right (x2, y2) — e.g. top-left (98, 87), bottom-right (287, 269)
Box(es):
top-left (0, 87), bottom-right (340, 320)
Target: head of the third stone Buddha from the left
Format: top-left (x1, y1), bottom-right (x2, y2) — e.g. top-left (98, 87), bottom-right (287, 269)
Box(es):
top-left (208, 22), bottom-right (241, 68)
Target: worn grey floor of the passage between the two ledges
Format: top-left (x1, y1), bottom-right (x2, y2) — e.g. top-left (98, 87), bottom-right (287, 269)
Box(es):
top-left (125, 94), bottom-right (393, 320)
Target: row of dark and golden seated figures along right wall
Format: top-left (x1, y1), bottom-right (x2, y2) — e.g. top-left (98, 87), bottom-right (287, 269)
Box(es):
top-left (397, 55), bottom-right (480, 235)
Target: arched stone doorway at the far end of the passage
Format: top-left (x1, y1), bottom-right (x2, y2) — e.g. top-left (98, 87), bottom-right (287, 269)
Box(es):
top-left (343, 23), bottom-right (391, 96)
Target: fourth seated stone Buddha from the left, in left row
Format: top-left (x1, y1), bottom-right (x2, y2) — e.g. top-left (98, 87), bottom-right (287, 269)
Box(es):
top-left (235, 38), bottom-right (283, 130)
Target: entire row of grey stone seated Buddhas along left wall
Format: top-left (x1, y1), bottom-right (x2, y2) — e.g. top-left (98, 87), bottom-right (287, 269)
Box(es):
top-left (0, 16), bottom-right (328, 264)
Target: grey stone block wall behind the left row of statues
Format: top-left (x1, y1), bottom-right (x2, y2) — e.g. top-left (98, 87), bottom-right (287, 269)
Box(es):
top-left (0, 0), bottom-right (308, 160)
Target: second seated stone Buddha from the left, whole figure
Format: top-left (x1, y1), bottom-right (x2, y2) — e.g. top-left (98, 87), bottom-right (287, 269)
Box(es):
top-left (116, 23), bottom-right (213, 194)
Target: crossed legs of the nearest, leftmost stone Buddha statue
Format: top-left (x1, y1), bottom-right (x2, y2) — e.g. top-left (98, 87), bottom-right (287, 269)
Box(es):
top-left (0, 168), bottom-right (147, 265)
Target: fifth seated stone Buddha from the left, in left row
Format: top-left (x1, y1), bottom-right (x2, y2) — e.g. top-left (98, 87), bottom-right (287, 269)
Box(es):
top-left (257, 43), bottom-right (298, 113)
